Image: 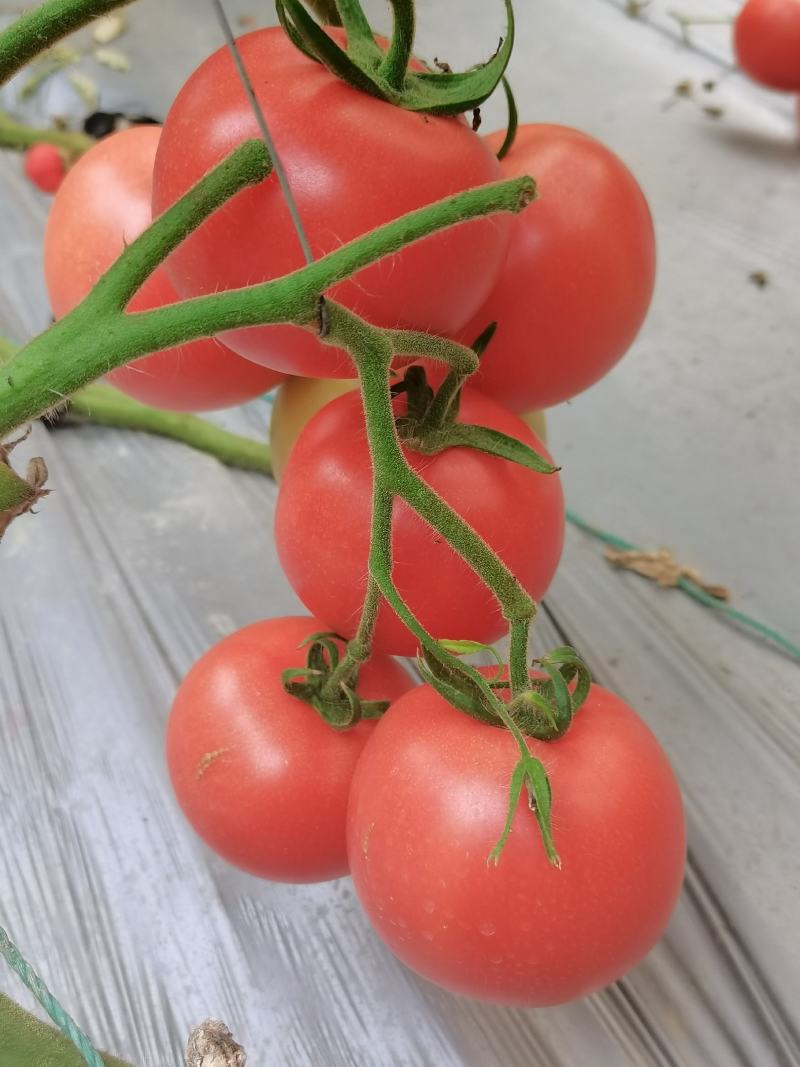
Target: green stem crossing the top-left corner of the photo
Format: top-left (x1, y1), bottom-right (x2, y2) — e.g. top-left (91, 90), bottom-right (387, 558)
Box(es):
top-left (0, 0), bottom-right (130, 85)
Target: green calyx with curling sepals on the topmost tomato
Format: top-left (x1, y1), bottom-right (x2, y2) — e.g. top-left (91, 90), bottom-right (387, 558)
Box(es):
top-left (275, 0), bottom-right (514, 116)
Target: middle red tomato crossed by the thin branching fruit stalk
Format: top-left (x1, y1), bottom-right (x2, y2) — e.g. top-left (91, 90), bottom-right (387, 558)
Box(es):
top-left (275, 389), bottom-right (564, 655)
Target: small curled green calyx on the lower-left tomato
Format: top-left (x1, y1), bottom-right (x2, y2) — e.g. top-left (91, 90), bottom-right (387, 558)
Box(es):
top-left (282, 633), bottom-right (389, 730)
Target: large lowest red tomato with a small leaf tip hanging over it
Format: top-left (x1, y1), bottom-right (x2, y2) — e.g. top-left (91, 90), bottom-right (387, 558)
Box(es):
top-left (348, 685), bottom-right (686, 1005)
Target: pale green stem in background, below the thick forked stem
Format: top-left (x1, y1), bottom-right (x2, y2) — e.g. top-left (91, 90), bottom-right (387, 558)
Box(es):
top-left (66, 384), bottom-right (272, 469)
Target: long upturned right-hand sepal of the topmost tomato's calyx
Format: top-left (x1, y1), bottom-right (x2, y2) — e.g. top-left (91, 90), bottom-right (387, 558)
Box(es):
top-left (402, 0), bottom-right (514, 115)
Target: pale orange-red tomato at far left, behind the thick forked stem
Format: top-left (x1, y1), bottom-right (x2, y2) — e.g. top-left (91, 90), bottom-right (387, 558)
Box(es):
top-left (45, 126), bottom-right (283, 411)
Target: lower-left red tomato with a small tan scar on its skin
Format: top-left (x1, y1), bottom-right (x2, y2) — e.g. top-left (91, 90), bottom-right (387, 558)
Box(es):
top-left (166, 617), bottom-right (413, 881)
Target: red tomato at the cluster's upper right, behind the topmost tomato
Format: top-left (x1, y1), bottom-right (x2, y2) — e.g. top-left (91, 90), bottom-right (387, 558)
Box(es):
top-left (459, 125), bottom-right (655, 411)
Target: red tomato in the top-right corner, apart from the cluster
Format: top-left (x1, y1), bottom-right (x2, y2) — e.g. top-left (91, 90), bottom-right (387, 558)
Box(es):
top-left (734, 0), bottom-right (800, 92)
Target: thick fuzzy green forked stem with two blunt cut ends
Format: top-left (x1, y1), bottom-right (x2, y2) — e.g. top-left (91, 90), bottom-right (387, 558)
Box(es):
top-left (0, 170), bottom-right (534, 439)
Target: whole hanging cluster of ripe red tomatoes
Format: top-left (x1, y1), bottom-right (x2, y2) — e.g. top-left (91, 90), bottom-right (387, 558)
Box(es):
top-left (46, 18), bottom-right (685, 1004)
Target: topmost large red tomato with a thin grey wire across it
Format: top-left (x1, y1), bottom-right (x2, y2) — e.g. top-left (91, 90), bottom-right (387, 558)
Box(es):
top-left (154, 28), bottom-right (510, 378)
